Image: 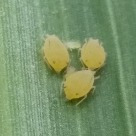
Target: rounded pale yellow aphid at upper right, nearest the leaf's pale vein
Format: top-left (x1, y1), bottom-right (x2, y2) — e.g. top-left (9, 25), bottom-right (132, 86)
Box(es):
top-left (80, 39), bottom-right (106, 70)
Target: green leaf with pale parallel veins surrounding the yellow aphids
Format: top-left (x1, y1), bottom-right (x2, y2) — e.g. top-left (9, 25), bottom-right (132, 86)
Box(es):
top-left (0, 0), bottom-right (136, 136)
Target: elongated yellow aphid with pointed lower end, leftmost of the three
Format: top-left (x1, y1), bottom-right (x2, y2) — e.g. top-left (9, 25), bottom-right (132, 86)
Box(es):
top-left (43, 35), bottom-right (70, 73)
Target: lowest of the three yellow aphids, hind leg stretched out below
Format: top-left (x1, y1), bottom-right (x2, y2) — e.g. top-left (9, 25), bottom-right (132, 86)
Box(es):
top-left (64, 70), bottom-right (95, 104)
